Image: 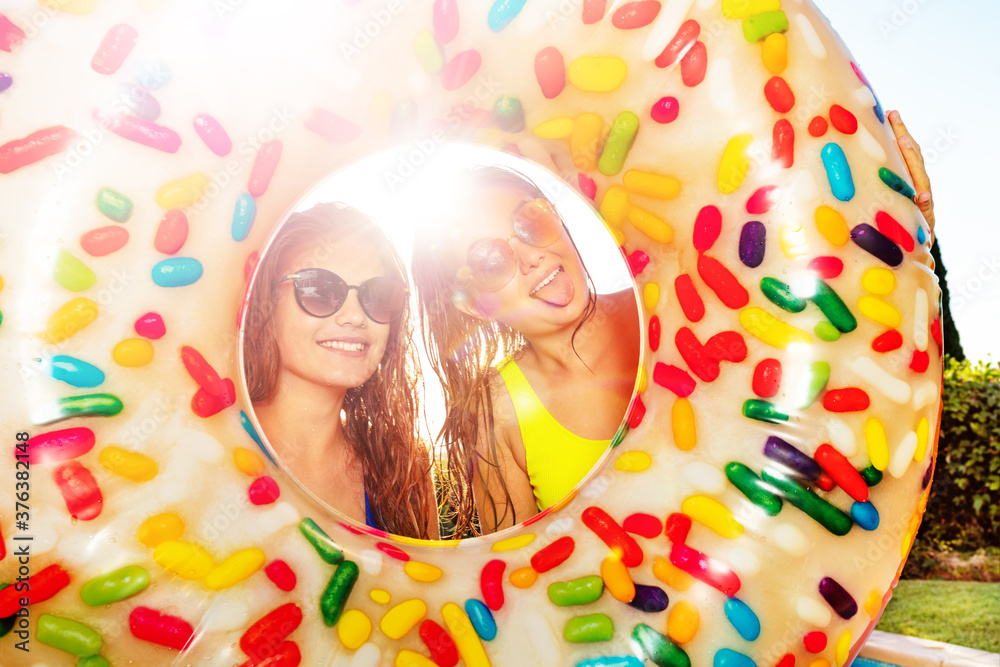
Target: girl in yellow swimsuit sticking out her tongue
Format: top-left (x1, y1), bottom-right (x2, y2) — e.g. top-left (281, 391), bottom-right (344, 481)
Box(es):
top-left (413, 166), bottom-right (640, 536)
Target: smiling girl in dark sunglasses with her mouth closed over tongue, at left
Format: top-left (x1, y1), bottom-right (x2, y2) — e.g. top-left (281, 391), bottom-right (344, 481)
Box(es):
top-left (243, 203), bottom-right (438, 539)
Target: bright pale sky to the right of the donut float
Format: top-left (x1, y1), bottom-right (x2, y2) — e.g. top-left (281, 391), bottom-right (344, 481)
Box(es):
top-left (815, 0), bottom-right (1000, 363)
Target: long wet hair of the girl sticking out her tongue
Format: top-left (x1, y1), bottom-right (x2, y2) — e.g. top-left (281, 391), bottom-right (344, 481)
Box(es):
top-left (412, 166), bottom-right (597, 536)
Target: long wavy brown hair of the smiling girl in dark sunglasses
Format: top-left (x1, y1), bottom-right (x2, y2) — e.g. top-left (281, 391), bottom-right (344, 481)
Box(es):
top-left (243, 203), bottom-right (436, 539)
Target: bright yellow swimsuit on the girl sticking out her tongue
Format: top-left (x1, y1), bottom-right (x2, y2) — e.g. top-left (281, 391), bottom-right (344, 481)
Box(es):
top-left (498, 360), bottom-right (611, 510)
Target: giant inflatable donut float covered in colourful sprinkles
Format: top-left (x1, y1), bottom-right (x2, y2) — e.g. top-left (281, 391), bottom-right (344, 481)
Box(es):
top-left (0, 0), bottom-right (941, 667)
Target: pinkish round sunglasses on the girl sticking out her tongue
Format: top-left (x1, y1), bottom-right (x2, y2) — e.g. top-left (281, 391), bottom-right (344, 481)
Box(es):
top-left (460, 199), bottom-right (564, 292)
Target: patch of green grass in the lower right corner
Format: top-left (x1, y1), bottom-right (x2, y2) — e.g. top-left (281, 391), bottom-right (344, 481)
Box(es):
top-left (877, 580), bottom-right (1000, 653)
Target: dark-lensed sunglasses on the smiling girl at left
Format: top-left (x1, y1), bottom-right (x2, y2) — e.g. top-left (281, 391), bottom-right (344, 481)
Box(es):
top-left (274, 269), bottom-right (410, 324)
